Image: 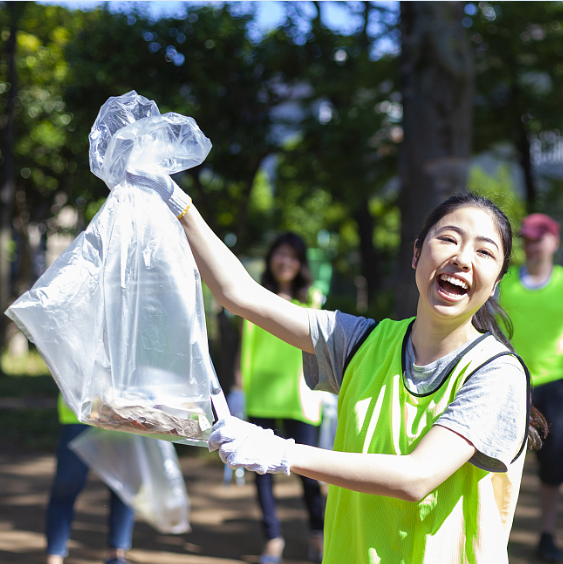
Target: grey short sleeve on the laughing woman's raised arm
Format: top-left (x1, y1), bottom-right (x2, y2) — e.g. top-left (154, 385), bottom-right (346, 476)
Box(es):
top-left (303, 309), bottom-right (375, 394)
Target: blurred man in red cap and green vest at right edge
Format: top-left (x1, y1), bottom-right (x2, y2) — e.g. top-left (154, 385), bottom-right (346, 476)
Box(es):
top-left (500, 213), bottom-right (563, 562)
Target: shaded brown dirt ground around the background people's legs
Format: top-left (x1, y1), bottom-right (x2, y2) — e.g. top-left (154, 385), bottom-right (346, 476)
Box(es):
top-left (0, 453), bottom-right (563, 564)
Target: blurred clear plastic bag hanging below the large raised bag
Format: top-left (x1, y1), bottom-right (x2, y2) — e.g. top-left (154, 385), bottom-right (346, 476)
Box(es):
top-left (69, 428), bottom-right (190, 534)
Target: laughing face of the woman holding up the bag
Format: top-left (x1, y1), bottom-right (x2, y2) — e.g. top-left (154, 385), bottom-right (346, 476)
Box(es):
top-left (413, 207), bottom-right (504, 320)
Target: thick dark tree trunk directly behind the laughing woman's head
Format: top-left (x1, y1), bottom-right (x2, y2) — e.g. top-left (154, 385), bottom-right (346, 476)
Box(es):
top-left (395, 2), bottom-right (473, 319)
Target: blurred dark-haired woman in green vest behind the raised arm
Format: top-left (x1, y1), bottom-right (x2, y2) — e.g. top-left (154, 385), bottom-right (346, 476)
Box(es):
top-left (231, 233), bottom-right (324, 564)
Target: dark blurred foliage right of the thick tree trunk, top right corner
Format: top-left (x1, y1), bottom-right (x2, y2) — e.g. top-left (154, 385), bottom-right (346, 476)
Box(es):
top-left (466, 2), bottom-right (563, 150)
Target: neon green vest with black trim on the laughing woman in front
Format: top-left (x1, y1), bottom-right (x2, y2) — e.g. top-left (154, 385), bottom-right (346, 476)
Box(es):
top-left (323, 320), bottom-right (525, 564)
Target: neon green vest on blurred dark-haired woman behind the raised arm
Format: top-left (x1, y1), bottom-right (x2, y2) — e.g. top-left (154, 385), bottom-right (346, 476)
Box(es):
top-left (241, 290), bottom-right (322, 425)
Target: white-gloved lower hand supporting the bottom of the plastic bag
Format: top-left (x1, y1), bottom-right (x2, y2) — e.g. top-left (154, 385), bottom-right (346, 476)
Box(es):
top-left (209, 415), bottom-right (295, 476)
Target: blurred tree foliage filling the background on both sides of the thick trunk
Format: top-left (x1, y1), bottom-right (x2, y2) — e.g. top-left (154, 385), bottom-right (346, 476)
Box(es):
top-left (7, 2), bottom-right (563, 322)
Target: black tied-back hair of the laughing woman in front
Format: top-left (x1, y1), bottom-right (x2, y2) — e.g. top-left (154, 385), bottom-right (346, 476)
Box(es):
top-left (415, 193), bottom-right (547, 448)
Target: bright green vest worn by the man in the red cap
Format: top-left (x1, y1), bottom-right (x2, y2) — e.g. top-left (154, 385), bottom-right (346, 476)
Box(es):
top-left (500, 265), bottom-right (563, 386)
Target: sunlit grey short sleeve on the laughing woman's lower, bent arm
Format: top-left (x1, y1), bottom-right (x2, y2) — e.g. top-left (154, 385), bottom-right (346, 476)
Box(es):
top-left (436, 355), bottom-right (528, 472)
